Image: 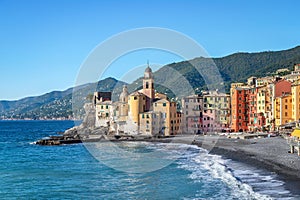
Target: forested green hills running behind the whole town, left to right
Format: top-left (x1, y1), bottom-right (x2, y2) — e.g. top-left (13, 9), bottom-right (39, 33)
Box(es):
top-left (0, 46), bottom-right (300, 119)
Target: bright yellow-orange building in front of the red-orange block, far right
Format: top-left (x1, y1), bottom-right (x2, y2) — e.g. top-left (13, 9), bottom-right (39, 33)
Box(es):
top-left (274, 94), bottom-right (293, 127)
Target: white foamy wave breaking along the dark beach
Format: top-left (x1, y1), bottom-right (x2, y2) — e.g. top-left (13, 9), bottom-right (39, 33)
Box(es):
top-left (163, 144), bottom-right (292, 200)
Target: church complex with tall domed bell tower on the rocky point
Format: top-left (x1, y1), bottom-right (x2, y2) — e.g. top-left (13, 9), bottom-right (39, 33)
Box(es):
top-left (93, 65), bottom-right (182, 136)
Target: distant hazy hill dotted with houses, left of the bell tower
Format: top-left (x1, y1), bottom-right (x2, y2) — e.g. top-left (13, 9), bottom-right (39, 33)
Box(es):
top-left (0, 78), bottom-right (126, 119)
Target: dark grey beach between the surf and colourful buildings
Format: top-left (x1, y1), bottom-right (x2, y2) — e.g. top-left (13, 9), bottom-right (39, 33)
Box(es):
top-left (178, 136), bottom-right (300, 195)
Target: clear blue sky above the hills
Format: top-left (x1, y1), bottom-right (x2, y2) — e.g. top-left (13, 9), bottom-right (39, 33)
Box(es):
top-left (0, 0), bottom-right (300, 100)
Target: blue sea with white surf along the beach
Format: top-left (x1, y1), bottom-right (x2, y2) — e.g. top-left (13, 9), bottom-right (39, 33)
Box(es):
top-left (0, 121), bottom-right (299, 200)
